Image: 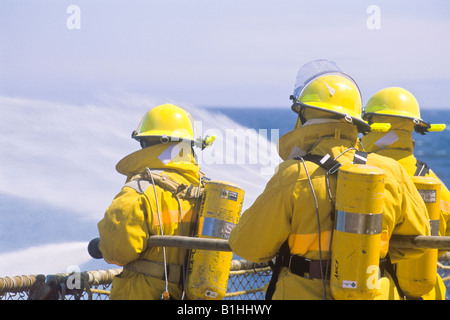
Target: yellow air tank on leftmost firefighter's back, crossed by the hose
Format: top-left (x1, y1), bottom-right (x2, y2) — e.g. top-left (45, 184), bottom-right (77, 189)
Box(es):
top-left (186, 181), bottom-right (244, 300)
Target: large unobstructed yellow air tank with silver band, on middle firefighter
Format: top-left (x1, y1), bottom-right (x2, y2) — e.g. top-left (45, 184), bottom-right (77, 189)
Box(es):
top-left (330, 164), bottom-right (385, 300)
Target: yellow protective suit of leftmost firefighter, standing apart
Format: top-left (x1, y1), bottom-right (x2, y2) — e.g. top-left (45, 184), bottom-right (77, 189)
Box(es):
top-left (98, 143), bottom-right (200, 300)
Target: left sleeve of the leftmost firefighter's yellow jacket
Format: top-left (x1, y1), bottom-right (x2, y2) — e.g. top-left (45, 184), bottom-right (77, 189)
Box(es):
top-left (98, 187), bottom-right (149, 266)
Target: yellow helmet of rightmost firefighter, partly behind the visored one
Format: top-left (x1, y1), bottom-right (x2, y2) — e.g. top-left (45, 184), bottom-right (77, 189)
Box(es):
top-left (363, 87), bottom-right (445, 134)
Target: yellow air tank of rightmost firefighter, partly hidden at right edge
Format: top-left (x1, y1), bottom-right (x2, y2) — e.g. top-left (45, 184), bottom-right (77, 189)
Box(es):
top-left (397, 176), bottom-right (441, 298)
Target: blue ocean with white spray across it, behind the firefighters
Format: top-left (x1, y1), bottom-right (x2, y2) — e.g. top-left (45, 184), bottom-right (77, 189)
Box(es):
top-left (0, 97), bottom-right (450, 284)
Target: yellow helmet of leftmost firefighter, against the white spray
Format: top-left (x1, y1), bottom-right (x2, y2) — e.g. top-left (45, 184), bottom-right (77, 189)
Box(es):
top-left (132, 104), bottom-right (195, 142)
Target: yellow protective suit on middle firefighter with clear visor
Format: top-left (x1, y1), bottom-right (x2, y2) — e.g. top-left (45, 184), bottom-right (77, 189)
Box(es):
top-left (229, 120), bottom-right (430, 299)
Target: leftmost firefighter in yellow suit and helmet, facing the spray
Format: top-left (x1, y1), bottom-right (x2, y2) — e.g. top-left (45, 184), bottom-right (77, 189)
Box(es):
top-left (98, 104), bottom-right (201, 300)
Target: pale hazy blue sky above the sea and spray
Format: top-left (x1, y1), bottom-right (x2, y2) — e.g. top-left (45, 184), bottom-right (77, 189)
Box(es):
top-left (0, 0), bottom-right (450, 108)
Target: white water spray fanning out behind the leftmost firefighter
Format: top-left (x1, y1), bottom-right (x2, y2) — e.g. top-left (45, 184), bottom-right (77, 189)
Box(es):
top-left (0, 96), bottom-right (278, 275)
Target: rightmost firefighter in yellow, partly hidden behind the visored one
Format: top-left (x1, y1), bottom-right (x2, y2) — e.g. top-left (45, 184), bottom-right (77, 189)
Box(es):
top-left (361, 87), bottom-right (450, 300)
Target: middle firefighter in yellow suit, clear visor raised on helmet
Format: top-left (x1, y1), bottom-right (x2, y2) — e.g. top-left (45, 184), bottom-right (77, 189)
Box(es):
top-left (229, 60), bottom-right (430, 300)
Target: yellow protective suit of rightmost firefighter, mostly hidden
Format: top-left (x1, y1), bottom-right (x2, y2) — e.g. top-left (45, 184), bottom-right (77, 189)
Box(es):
top-left (361, 116), bottom-right (450, 300)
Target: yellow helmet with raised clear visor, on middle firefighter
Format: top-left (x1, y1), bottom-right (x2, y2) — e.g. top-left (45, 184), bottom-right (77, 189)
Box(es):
top-left (291, 60), bottom-right (370, 133)
